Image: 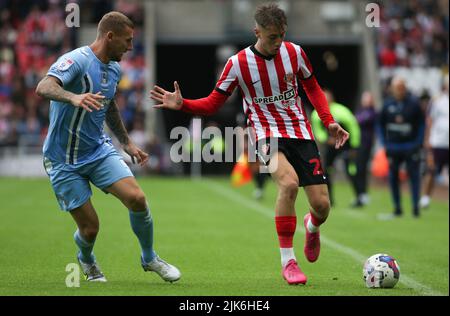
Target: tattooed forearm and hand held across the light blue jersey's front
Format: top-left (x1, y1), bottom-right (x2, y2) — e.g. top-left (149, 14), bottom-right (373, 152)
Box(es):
top-left (36, 76), bottom-right (105, 112)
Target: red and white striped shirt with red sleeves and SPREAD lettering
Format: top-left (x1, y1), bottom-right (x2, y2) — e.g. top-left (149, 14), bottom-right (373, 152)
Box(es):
top-left (183, 42), bottom-right (333, 140)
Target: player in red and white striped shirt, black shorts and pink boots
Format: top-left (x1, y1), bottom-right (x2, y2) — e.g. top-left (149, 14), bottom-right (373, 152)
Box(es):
top-left (151, 4), bottom-right (349, 284)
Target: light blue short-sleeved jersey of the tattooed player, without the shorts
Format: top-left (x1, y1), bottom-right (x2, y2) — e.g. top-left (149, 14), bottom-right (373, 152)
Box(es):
top-left (43, 46), bottom-right (121, 165)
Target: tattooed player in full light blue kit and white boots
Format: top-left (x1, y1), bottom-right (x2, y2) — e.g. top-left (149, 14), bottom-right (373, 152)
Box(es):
top-left (36, 12), bottom-right (181, 282)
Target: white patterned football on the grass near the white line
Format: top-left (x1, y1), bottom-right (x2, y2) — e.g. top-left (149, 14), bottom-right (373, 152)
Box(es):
top-left (363, 253), bottom-right (400, 288)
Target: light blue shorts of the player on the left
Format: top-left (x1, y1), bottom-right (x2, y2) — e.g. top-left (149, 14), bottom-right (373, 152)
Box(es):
top-left (44, 151), bottom-right (133, 211)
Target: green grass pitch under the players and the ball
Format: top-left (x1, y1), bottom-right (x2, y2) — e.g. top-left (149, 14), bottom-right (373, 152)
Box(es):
top-left (0, 177), bottom-right (449, 296)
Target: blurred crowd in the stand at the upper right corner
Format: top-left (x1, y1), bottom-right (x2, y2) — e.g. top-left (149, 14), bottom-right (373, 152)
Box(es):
top-left (377, 0), bottom-right (449, 69)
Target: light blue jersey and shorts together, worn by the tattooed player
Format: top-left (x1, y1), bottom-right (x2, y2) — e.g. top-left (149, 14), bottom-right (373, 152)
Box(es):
top-left (43, 46), bottom-right (133, 211)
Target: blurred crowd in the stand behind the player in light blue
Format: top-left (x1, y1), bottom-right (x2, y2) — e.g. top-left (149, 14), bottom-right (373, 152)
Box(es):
top-left (0, 0), bottom-right (146, 147)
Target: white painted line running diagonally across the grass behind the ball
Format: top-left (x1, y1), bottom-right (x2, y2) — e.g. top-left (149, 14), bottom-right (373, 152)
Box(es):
top-left (204, 180), bottom-right (447, 296)
